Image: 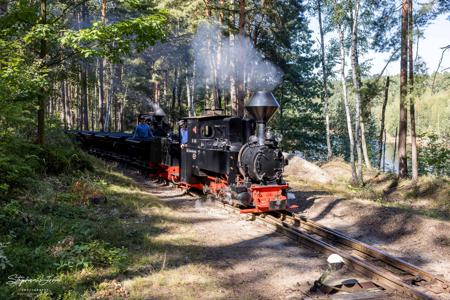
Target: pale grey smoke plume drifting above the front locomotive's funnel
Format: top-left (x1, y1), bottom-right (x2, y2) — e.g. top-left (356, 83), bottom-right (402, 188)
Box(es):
top-left (192, 22), bottom-right (283, 91)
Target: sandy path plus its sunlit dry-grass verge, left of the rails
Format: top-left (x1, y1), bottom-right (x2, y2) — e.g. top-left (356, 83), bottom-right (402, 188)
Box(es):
top-left (117, 170), bottom-right (402, 299)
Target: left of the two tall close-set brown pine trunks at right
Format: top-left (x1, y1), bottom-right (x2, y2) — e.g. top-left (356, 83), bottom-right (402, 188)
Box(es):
top-left (398, 0), bottom-right (408, 178)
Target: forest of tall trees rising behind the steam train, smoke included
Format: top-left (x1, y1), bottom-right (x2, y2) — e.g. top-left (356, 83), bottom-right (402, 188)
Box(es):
top-left (0, 1), bottom-right (449, 181)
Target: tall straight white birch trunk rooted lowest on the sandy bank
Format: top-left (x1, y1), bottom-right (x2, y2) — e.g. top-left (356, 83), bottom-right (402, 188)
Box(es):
top-left (351, 0), bottom-right (363, 185)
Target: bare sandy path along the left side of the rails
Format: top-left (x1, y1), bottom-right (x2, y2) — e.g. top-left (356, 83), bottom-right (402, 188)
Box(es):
top-left (122, 169), bottom-right (408, 299)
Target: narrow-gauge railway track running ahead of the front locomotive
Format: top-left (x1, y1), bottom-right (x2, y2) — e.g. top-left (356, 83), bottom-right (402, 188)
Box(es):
top-left (220, 203), bottom-right (450, 299)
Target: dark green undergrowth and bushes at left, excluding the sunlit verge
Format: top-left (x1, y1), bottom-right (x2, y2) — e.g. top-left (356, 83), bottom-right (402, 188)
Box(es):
top-left (0, 128), bottom-right (187, 299)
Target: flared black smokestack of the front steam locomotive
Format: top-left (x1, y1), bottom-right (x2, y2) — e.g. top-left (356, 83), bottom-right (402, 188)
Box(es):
top-left (245, 91), bottom-right (280, 145)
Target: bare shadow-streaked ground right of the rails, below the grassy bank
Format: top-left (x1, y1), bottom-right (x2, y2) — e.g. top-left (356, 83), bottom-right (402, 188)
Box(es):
top-left (296, 188), bottom-right (450, 281)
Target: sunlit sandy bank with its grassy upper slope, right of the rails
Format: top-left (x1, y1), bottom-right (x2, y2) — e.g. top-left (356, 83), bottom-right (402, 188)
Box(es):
top-left (286, 160), bottom-right (450, 281)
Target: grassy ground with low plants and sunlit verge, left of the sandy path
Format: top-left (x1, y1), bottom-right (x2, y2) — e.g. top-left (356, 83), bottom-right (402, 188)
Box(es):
top-left (0, 151), bottom-right (220, 299)
